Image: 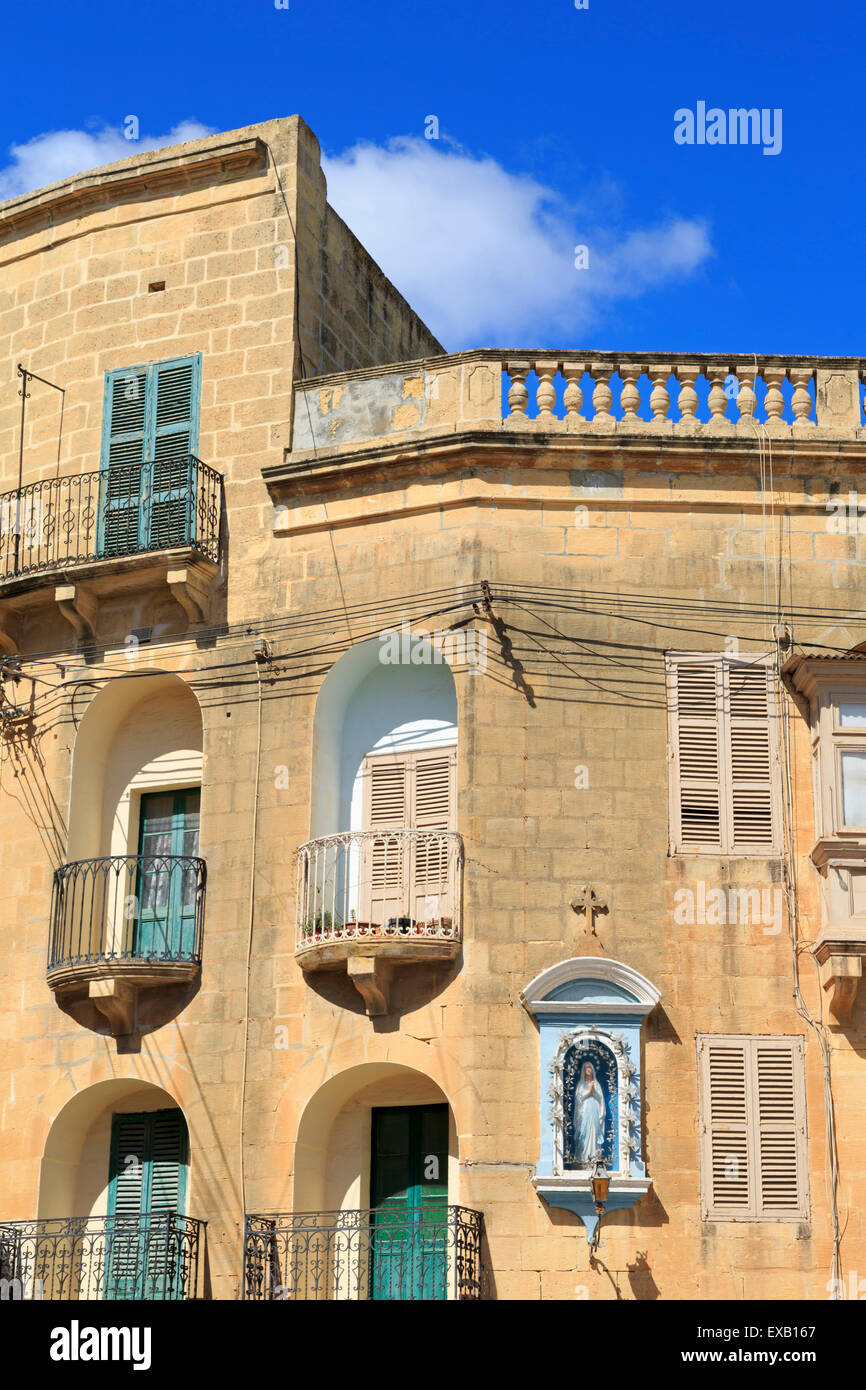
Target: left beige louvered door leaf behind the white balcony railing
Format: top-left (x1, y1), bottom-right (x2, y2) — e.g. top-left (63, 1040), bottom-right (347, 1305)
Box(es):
top-left (360, 753), bottom-right (411, 926)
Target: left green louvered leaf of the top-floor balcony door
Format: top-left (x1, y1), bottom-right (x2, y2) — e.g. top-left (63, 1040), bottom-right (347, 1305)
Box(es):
top-left (99, 367), bottom-right (149, 556)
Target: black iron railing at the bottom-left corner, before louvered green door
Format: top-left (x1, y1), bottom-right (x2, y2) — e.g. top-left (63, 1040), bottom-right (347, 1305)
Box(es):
top-left (0, 1212), bottom-right (207, 1300)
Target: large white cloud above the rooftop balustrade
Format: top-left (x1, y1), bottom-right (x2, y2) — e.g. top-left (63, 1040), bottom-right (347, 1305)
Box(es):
top-left (322, 136), bottom-right (712, 349)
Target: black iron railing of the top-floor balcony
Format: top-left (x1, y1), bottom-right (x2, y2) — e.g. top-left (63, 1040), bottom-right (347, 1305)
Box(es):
top-left (0, 455), bottom-right (222, 580)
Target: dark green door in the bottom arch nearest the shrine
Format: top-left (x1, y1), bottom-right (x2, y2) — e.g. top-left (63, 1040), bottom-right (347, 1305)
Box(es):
top-left (370, 1105), bottom-right (448, 1301)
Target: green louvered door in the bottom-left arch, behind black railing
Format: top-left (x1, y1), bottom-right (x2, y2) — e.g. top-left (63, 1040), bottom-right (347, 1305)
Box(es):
top-left (104, 1111), bottom-right (189, 1298)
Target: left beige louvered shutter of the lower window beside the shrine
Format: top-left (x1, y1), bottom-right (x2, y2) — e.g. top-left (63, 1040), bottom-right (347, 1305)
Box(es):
top-left (698, 1038), bottom-right (753, 1220)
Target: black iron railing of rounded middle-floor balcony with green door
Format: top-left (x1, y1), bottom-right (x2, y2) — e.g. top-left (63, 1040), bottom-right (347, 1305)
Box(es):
top-left (49, 855), bottom-right (207, 972)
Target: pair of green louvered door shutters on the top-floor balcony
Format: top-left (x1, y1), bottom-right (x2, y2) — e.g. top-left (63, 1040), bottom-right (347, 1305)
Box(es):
top-left (97, 354), bottom-right (202, 557)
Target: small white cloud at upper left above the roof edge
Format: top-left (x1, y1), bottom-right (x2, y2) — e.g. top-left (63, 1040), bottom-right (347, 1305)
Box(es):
top-left (0, 121), bottom-right (213, 200)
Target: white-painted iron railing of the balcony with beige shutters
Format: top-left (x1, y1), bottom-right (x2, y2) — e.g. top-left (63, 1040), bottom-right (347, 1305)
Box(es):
top-left (295, 830), bottom-right (463, 951)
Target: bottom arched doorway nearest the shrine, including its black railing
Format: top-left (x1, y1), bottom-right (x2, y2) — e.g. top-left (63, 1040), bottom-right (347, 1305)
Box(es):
top-left (246, 1062), bottom-right (481, 1302)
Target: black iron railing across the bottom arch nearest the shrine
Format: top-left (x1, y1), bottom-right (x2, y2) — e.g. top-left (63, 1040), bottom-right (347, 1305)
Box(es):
top-left (243, 1205), bottom-right (481, 1302)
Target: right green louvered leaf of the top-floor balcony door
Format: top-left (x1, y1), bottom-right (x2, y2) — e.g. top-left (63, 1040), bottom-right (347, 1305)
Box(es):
top-left (147, 357), bottom-right (199, 550)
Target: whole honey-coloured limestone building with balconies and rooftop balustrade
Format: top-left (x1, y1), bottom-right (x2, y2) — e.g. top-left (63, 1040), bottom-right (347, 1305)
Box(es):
top-left (0, 117), bottom-right (866, 1300)
